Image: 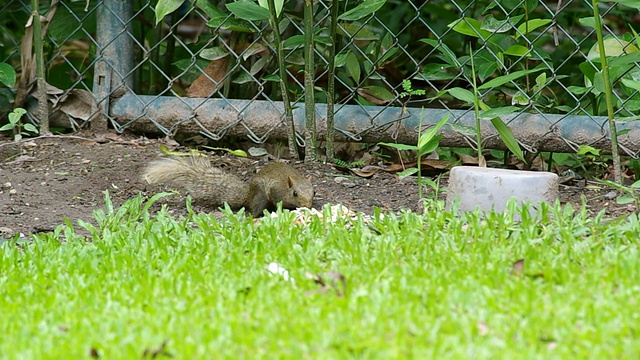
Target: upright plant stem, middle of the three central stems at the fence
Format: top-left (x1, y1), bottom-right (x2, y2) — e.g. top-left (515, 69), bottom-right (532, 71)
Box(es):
top-left (304, 0), bottom-right (317, 162)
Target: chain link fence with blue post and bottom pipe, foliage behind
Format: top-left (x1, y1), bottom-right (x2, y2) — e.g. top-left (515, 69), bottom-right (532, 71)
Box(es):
top-left (0, 0), bottom-right (640, 157)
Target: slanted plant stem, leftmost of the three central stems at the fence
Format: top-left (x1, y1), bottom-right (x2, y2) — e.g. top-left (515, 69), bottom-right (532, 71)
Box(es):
top-left (269, 0), bottom-right (300, 160)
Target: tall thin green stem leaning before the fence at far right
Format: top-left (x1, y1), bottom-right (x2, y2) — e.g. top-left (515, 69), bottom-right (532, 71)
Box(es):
top-left (591, 0), bottom-right (622, 184)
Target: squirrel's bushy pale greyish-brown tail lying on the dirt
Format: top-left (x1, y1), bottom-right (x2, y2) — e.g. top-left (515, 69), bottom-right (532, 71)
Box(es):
top-left (142, 156), bottom-right (249, 209)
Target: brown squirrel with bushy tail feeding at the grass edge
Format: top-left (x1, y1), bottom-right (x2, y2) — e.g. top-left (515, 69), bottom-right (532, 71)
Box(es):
top-left (142, 156), bottom-right (314, 217)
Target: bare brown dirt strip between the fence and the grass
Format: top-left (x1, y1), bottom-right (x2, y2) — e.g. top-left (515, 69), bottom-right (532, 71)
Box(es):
top-left (0, 132), bottom-right (636, 238)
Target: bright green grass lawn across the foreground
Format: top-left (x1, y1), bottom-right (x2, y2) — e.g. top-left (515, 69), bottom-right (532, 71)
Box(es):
top-left (0, 194), bottom-right (640, 359)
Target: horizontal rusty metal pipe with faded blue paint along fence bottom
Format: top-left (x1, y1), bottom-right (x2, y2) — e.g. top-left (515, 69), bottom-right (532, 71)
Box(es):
top-left (111, 93), bottom-right (640, 155)
